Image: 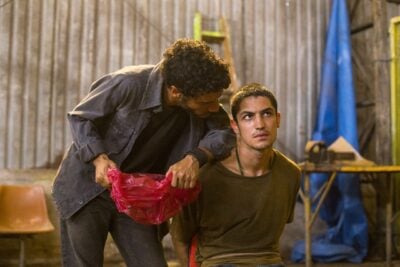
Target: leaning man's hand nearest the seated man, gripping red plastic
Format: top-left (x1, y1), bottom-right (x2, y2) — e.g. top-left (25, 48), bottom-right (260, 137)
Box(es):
top-left (167, 154), bottom-right (199, 188)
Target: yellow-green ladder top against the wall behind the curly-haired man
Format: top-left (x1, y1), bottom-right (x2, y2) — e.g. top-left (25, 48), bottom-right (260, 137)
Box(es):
top-left (193, 12), bottom-right (238, 94)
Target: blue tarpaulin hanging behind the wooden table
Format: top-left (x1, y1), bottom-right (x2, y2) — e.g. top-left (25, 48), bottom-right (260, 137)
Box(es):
top-left (292, 0), bottom-right (368, 263)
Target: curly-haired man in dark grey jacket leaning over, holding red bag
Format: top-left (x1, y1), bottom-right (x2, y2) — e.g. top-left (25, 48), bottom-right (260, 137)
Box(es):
top-left (53, 39), bottom-right (234, 267)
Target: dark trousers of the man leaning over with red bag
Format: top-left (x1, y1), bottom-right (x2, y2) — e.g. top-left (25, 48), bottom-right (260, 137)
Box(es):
top-left (60, 191), bottom-right (167, 267)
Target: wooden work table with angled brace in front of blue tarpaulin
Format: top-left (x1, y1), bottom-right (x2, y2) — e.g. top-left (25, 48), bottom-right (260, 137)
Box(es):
top-left (299, 162), bottom-right (400, 267)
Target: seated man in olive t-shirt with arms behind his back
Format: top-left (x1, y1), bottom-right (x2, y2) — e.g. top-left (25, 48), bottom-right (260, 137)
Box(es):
top-left (171, 84), bottom-right (300, 267)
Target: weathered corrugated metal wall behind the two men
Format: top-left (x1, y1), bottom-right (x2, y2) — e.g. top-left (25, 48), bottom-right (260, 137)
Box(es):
top-left (0, 0), bottom-right (331, 168)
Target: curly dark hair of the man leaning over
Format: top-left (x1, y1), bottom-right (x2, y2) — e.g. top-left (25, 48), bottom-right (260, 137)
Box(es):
top-left (161, 39), bottom-right (231, 97)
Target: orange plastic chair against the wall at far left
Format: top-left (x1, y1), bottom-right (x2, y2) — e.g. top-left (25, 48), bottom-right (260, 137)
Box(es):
top-left (0, 185), bottom-right (54, 266)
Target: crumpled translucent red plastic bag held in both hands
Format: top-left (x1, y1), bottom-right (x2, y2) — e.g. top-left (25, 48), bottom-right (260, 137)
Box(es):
top-left (107, 168), bottom-right (201, 224)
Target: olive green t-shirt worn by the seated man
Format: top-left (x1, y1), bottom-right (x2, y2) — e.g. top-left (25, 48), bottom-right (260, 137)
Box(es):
top-left (170, 150), bottom-right (300, 267)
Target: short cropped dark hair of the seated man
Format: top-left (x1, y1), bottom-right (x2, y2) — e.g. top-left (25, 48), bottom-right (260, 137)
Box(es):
top-left (231, 83), bottom-right (278, 122)
